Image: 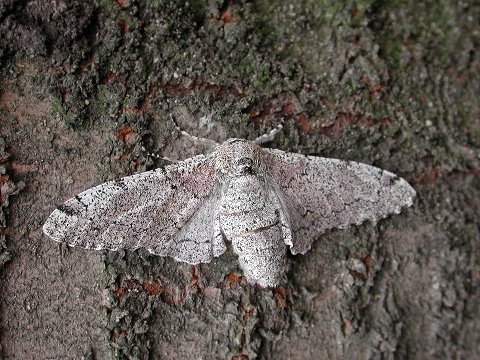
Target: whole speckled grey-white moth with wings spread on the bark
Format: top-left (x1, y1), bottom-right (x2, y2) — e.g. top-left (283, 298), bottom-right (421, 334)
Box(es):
top-left (43, 139), bottom-right (415, 287)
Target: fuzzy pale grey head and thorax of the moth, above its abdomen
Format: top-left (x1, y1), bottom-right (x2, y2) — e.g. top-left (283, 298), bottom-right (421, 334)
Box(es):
top-left (216, 139), bottom-right (266, 180)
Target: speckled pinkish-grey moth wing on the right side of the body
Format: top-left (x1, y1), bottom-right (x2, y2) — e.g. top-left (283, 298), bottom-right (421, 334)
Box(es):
top-left (264, 149), bottom-right (415, 254)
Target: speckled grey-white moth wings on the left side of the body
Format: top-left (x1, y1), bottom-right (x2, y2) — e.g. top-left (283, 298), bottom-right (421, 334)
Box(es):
top-left (43, 155), bottom-right (224, 264)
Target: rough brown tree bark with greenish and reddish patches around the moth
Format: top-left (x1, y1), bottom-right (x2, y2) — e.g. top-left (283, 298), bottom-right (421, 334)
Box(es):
top-left (0, 0), bottom-right (480, 359)
